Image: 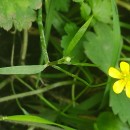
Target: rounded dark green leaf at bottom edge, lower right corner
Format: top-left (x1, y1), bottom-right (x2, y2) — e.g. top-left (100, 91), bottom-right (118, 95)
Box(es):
top-left (95, 112), bottom-right (129, 130)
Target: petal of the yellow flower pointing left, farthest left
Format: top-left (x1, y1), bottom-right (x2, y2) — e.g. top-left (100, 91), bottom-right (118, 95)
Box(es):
top-left (108, 67), bottom-right (122, 79)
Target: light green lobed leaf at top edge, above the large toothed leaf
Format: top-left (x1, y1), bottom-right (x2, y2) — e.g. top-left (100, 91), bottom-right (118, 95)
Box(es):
top-left (88, 0), bottom-right (112, 23)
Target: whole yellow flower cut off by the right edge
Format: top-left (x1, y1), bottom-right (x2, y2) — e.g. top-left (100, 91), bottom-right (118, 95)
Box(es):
top-left (108, 62), bottom-right (130, 98)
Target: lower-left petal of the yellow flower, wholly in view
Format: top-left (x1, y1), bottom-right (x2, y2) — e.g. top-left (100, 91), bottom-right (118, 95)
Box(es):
top-left (113, 80), bottom-right (126, 94)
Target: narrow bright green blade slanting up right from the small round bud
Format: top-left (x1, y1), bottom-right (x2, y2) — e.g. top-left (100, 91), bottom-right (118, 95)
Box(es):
top-left (64, 16), bottom-right (93, 56)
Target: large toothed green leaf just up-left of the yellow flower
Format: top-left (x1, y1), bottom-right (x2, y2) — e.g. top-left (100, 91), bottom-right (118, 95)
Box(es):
top-left (84, 23), bottom-right (114, 73)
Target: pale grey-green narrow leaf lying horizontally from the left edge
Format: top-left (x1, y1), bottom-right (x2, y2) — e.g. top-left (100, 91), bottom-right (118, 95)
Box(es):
top-left (0, 65), bottom-right (47, 75)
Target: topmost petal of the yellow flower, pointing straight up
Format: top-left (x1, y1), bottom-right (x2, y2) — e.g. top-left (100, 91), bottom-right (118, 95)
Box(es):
top-left (120, 61), bottom-right (130, 74)
